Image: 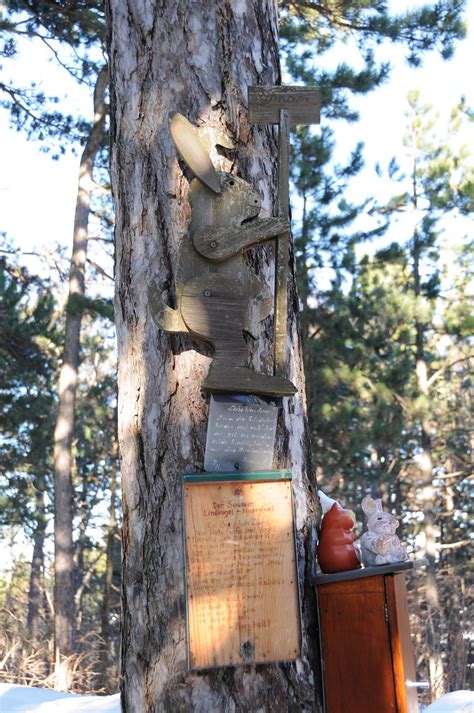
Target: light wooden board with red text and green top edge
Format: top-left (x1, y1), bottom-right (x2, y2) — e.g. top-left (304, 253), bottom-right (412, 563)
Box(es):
top-left (183, 472), bottom-right (300, 669)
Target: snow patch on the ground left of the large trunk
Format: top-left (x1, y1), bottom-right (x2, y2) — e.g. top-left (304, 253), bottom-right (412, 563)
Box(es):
top-left (0, 683), bottom-right (120, 713)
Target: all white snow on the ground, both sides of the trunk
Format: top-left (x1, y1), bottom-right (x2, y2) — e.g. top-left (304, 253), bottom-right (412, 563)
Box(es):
top-left (0, 683), bottom-right (474, 713)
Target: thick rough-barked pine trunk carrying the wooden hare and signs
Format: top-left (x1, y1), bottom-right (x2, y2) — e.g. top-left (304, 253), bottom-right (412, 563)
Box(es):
top-left (106, 0), bottom-right (321, 713)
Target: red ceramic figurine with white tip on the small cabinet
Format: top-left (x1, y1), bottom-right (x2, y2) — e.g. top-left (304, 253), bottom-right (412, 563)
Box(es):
top-left (316, 491), bottom-right (361, 574)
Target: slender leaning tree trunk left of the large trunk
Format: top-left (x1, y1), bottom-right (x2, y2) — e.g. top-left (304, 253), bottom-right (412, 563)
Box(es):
top-left (54, 67), bottom-right (108, 690)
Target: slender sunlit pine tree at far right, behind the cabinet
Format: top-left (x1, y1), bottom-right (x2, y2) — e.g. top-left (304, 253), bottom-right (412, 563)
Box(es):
top-left (378, 91), bottom-right (474, 698)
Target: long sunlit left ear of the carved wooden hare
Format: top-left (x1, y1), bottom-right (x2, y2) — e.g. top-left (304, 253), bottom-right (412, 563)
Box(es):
top-left (170, 112), bottom-right (221, 193)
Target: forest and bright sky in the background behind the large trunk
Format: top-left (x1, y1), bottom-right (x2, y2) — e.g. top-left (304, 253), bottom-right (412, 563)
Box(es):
top-left (0, 1), bottom-right (474, 699)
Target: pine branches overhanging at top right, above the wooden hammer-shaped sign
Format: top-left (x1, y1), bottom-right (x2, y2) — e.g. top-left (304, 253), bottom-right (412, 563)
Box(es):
top-left (280, 0), bottom-right (466, 121)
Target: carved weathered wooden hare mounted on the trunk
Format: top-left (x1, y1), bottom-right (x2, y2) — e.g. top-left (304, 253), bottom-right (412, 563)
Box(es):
top-left (149, 114), bottom-right (296, 396)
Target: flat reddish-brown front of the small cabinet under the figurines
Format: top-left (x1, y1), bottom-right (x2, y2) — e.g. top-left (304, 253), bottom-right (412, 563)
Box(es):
top-left (319, 576), bottom-right (398, 713)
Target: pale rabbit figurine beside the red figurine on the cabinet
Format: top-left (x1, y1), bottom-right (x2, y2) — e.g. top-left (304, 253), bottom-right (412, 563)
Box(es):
top-left (360, 495), bottom-right (408, 567)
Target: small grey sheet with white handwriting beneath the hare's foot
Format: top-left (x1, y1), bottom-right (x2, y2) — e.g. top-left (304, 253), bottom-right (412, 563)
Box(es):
top-left (204, 394), bottom-right (278, 473)
